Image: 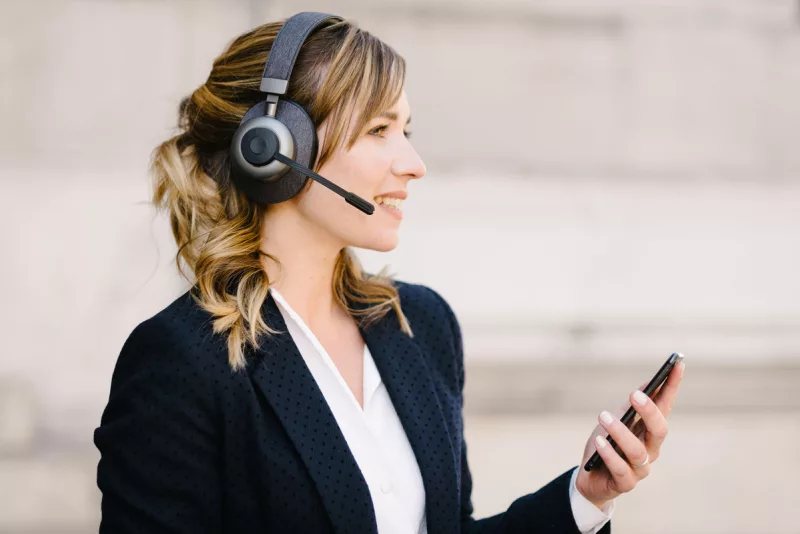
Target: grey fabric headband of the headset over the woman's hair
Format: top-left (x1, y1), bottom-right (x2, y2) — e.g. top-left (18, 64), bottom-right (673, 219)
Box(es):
top-left (261, 11), bottom-right (343, 97)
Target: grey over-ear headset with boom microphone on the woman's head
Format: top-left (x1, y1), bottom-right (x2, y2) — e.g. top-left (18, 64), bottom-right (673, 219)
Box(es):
top-left (229, 11), bottom-right (375, 215)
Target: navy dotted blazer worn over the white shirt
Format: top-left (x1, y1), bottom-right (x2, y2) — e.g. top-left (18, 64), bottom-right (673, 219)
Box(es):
top-left (94, 281), bottom-right (610, 534)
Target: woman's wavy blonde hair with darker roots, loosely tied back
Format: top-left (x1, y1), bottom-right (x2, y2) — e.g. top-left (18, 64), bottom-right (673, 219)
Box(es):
top-left (150, 15), bottom-right (413, 370)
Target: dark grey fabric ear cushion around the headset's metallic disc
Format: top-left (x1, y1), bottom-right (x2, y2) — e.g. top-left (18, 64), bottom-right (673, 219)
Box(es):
top-left (233, 99), bottom-right (317, 204)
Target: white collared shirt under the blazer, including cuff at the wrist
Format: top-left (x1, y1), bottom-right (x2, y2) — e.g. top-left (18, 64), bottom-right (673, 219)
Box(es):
top-left (270, 287), bottom-right (614, 534)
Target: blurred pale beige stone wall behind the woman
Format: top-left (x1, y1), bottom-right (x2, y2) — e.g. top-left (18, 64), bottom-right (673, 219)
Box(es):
top-left (0, 0), bottom-right (800, 534)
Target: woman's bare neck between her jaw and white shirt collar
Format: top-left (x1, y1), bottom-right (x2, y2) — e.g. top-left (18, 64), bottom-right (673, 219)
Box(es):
top-left (261, 203), bottom-right (344, 329)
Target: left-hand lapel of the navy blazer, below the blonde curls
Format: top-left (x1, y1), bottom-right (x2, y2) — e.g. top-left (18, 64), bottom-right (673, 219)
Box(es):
top-left (251, 294), bottom-right (377, 534)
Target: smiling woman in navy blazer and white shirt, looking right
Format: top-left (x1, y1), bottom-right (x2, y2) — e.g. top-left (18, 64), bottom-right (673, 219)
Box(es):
top-left (94, 12), bottom-right (682, 534)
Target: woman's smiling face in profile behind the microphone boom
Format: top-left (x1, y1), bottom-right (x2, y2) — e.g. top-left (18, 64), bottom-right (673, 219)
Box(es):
top-left (293, 91), bottom-right (425, 251)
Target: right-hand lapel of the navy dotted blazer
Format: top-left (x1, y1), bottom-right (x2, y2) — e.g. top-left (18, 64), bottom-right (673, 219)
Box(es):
top-left (361, 302), bottom-right (460, 534)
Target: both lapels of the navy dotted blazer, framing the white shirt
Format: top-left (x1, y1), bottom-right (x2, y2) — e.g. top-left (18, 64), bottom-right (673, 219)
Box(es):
top-left (248, 292), bottom-right (459, 534)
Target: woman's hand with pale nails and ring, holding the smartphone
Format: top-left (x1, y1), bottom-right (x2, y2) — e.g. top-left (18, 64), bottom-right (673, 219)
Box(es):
top-left (575, 362), bottom-right (685, 508)
